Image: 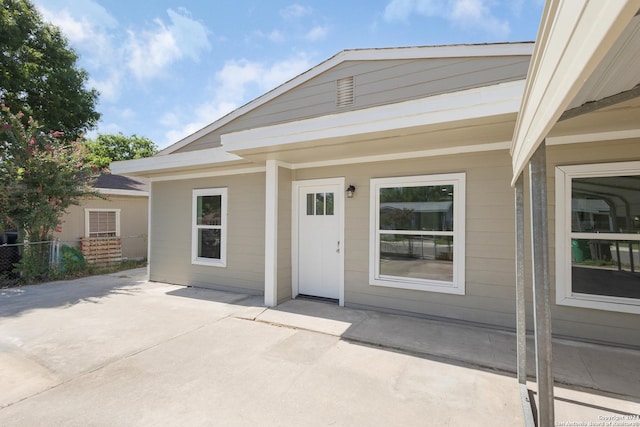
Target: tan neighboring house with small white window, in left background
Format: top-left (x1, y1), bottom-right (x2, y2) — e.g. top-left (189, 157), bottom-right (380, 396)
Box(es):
top-left (55, 174), bottom-right (149, 259)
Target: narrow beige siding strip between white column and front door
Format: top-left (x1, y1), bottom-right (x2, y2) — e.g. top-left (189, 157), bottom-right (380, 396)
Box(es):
top-left (278, 167), bottom-right (292, 304)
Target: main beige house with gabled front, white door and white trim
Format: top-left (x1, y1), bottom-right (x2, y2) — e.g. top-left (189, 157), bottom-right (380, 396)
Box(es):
top-left (112, 5), bottom-right (640, 362)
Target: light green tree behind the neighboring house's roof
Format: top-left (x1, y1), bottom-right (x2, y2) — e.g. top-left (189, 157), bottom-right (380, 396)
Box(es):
top-left (86, 133), bottom-right (158, 168)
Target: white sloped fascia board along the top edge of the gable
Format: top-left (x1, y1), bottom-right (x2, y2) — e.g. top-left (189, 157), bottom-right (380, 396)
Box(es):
top-left (158, 42), bottom-right (533, 155)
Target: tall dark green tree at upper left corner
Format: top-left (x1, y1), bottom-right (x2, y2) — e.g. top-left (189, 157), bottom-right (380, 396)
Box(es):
top-left (0, 0), bottom-right (100, 141)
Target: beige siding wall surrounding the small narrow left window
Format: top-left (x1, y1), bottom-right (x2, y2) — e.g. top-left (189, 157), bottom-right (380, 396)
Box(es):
top-left (150, 173), bottom-right (265, 294)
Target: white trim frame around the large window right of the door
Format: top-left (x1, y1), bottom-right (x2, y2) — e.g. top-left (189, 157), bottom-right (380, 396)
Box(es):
top-left (369, 173), bottom-right (466, 295)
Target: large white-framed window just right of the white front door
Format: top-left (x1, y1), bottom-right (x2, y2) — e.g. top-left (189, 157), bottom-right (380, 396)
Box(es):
top-left (369, 173), bottom-right (465, 295)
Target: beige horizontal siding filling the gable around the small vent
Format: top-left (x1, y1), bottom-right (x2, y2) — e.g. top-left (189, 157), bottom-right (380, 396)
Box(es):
top-left (176, 56), bottom-right (529, 152)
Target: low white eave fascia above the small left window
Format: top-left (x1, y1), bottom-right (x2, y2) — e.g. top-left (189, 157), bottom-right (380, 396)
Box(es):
top-left (110, 147), bottom-right (242, 175)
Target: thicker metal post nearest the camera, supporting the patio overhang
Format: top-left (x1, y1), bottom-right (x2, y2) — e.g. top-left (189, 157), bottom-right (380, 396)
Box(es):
top-left (529, 141), bottom-right (555, 427)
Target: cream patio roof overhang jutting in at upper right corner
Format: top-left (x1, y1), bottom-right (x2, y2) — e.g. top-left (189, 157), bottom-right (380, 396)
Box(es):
top-left (511, 0), bottom-right (640, 185)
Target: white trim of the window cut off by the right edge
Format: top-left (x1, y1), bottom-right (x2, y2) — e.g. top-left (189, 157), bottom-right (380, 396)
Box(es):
top-left (555, 162), bottom-right (640, 314)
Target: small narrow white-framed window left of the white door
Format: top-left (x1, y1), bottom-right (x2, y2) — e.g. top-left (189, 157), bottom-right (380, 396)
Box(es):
top-left (191, 188), bottom-right (227, 267)
